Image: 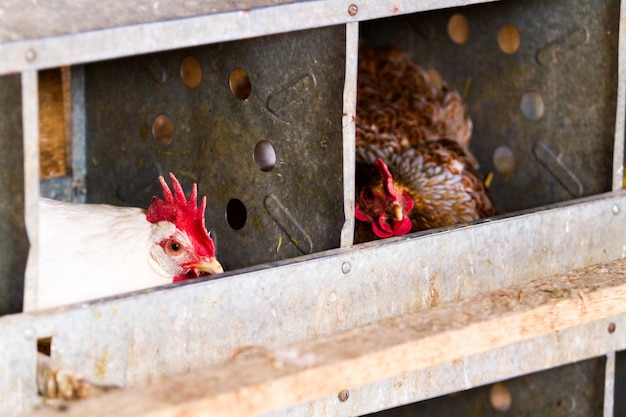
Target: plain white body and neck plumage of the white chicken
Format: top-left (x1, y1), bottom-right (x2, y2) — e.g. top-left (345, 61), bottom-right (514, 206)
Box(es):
top-left (36, 198), bottom-right (175, 308)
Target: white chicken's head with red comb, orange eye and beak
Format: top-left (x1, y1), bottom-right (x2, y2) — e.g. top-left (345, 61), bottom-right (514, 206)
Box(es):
top-left (146, 173), bottom-right (224, 282)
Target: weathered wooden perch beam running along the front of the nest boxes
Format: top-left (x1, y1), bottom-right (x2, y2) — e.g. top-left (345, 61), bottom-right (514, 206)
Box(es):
top-left (37, 260), bottom-right (626, 417)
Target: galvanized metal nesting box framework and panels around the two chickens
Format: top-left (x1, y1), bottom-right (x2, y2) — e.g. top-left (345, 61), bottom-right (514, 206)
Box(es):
top-left (0, 0), bottom-right (626, 416)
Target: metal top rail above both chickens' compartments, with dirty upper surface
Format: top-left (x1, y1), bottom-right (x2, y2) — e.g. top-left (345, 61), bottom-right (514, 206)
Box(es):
top-left (0, 0), bottom-right (498, 75)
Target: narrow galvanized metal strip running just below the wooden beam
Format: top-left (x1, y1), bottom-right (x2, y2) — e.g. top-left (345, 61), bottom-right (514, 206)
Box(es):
top-left (263, 314), bottom-right (626, 417)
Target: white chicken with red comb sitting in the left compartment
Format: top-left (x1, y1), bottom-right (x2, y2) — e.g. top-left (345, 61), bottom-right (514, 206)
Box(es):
top-left (36, 173), bottom-right (223, 308)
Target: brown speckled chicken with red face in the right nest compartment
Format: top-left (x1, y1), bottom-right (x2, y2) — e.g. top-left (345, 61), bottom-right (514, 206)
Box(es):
top-left (355, 45), bottom-right (495, 243)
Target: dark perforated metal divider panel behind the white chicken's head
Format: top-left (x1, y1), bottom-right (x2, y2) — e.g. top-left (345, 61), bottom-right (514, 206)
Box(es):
top-left (85, 26), bottom-right (345, 270)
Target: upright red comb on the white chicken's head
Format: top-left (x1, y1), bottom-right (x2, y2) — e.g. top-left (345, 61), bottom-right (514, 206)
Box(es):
top-left (146, 172), bottom-right (215, 256)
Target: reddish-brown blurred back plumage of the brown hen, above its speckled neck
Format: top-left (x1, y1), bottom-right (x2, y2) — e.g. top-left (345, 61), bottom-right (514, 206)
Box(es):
top-left (357, 45), bottom-right (472, 151)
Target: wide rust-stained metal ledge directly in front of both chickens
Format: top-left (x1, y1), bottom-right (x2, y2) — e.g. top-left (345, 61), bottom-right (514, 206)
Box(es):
top-left (0, 191), bottom-right (626, 416)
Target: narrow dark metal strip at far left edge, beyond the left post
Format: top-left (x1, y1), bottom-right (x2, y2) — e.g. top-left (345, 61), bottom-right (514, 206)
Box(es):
top-left (0, 75), bottom-right (28, 316)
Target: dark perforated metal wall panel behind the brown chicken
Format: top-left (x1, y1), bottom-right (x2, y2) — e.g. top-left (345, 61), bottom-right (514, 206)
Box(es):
top-left (362, 0), bottom-right (623, 213)
